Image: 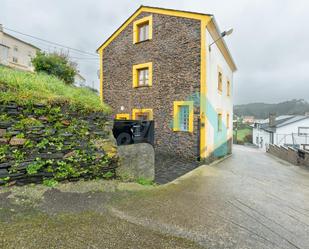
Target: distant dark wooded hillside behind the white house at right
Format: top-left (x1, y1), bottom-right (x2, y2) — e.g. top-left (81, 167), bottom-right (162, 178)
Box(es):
top-left (234, 99), bottom-right (309, 118)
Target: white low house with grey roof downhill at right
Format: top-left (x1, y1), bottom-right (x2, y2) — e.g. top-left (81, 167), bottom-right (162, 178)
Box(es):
top-left (252, 115), bottom-right (309, 149)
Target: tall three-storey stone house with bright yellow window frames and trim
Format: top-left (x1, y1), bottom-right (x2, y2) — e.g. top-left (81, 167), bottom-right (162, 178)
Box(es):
top-left (97, 6), bottom-right (236, 160)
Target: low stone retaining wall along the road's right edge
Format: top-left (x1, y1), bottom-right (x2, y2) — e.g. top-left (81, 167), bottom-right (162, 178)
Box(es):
top-left (267, 144), bottom-right (309, 167)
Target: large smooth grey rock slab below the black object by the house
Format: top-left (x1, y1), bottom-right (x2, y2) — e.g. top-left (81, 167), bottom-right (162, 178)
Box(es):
top-left (116, 143), bottom-right (155, 181)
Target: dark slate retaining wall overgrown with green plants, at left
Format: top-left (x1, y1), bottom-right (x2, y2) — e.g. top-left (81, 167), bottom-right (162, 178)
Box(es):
top-left (0, 102), bottom-right (118, 185)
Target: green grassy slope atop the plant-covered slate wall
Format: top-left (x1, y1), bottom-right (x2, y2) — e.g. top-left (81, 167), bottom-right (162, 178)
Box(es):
top-left (0, 66), bottom-right (110, 112)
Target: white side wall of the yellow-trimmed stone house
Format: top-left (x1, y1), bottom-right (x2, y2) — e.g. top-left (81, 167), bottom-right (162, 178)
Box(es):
top-left (206, 29), bottom-right (233, 151)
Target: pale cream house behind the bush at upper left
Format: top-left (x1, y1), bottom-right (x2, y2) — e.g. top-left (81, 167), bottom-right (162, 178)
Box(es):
top-left (0, 24), bottom-right (40, 71)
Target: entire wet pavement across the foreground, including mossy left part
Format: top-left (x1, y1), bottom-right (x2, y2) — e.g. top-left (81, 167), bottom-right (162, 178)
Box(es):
top-left (0, 146), bottom-right (309, 249)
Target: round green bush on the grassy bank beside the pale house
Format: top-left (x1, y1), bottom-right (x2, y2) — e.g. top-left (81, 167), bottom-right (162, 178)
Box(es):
top-left (32, 52), bottom-right (76, 84)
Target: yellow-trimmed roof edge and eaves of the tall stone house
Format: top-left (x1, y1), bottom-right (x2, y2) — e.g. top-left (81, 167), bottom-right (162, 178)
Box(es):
top-left (96, 5), bottom-right (237, 71)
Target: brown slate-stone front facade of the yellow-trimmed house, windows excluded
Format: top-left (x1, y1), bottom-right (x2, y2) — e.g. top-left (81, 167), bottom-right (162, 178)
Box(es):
top-left (103, 13), bottom-right (200, 159)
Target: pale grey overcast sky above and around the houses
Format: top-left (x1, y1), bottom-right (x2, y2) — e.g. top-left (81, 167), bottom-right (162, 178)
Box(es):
top-left (0, 0), bottom-right (309, 103)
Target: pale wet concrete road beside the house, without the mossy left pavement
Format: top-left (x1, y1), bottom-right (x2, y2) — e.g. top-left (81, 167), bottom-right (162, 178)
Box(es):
top-left (113, 146), bottom-right (309, 249)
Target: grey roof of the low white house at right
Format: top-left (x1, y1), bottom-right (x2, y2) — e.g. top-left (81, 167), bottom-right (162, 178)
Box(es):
top-left (255, 115), bottom-right (309, 132)
